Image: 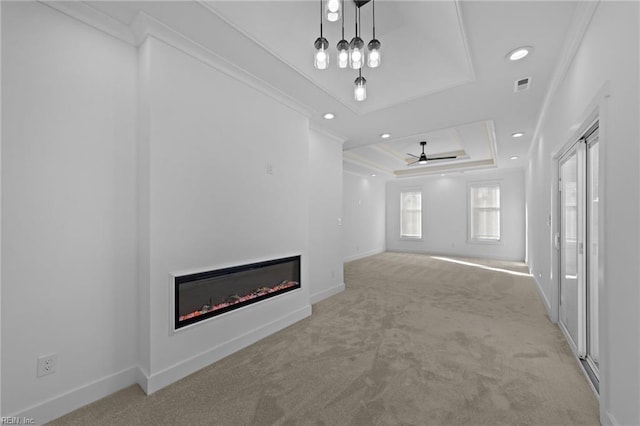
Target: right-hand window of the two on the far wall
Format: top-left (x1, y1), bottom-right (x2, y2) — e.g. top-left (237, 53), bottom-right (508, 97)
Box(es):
top-left (469, 183), bottom-right (500, 242)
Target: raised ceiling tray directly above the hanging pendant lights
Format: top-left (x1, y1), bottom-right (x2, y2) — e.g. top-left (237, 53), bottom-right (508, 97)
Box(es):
top-left (207, 1), bottom-right (473, 115)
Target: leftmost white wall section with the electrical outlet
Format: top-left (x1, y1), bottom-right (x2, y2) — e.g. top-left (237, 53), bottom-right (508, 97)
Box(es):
top-left (2, 2), bottom-right (137, 420)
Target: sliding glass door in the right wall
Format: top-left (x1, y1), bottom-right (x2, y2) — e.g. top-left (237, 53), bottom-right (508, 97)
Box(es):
top-left (558, 123), bottom-right (602, 388)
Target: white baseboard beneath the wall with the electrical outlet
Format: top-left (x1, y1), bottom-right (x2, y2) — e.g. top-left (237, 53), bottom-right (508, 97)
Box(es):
top-left (9, 367), bottom-right (139, 424)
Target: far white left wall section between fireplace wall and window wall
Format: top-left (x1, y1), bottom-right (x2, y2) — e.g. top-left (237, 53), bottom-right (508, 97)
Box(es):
top-left (342, 172), bottom-right (385, 262)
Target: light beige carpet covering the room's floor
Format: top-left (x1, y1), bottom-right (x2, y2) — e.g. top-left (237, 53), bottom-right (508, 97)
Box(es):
top-left (51, 253), bottom-right (599, 425)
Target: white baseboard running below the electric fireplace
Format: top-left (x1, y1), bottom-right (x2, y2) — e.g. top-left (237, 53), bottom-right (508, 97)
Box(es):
top-left (138, 305), bottom-right (311, 395)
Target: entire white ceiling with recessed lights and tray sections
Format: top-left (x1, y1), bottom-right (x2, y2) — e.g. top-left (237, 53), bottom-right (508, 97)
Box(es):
top-left (84, 0), bottom-right (580, 177)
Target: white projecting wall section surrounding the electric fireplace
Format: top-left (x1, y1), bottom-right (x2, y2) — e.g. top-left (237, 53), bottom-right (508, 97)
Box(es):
top-left (139, 37), bottom-right (311, 392)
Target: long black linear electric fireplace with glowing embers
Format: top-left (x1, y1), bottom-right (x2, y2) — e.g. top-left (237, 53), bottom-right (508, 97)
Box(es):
top-left (174, 256), bottom-right (300, 330)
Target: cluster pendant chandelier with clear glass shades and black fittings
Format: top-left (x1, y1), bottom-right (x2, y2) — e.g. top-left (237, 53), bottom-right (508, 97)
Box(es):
top-left (313, 0), bottom-right (381, 102)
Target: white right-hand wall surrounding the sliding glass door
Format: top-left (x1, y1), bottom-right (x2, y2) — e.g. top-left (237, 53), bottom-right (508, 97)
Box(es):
top-left (527, 2), bottom-right (640, 425)
